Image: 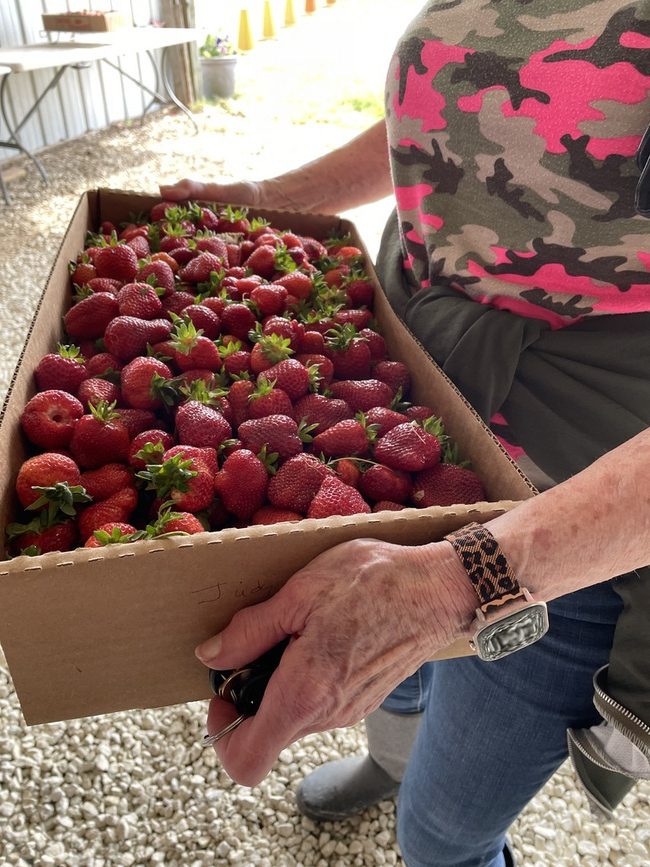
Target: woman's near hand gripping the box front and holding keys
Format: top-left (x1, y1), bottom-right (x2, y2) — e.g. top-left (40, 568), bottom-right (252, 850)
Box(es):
top-left (197, 539), bottom-right (476, 786)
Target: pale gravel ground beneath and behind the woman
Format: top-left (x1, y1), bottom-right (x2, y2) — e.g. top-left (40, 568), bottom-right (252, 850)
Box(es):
top-left (0, 0), bottom-right (650, 867)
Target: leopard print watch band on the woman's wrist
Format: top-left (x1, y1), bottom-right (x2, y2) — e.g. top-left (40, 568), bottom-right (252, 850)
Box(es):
top-left (445, 523), bottom-right (521, 605)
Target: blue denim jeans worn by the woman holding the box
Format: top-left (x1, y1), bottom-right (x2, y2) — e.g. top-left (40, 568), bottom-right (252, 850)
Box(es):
top-left (382, 582), bottom-right (621, 867)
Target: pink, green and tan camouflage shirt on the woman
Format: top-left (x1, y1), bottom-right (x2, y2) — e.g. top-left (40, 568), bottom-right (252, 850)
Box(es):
top-left (386, 0), bottom-right (650, 329)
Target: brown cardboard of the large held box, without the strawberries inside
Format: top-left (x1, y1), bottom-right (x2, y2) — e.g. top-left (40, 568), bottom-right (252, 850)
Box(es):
top-left (0, 189), bottom-right (534, 725)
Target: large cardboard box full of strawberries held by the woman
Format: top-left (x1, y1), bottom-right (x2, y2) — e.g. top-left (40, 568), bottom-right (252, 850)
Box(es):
top-left (0, 189), bottom-right (534, 724)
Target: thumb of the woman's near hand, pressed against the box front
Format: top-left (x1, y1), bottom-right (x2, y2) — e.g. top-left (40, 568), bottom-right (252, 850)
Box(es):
top-left (195, 591), bottom-right (290, 669)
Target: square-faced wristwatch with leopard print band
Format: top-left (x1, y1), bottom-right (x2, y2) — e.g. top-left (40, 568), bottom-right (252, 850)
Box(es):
top-left (445, 524), bottom-right (548, 662)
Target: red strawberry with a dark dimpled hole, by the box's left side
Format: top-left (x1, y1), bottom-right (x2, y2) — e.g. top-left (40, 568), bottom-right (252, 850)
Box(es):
top-left (20, 389), bottom-right (84, 449)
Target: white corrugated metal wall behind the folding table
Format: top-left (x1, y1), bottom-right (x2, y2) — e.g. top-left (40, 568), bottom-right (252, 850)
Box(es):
top-left (0, 0), bottom-right (161, 160)
